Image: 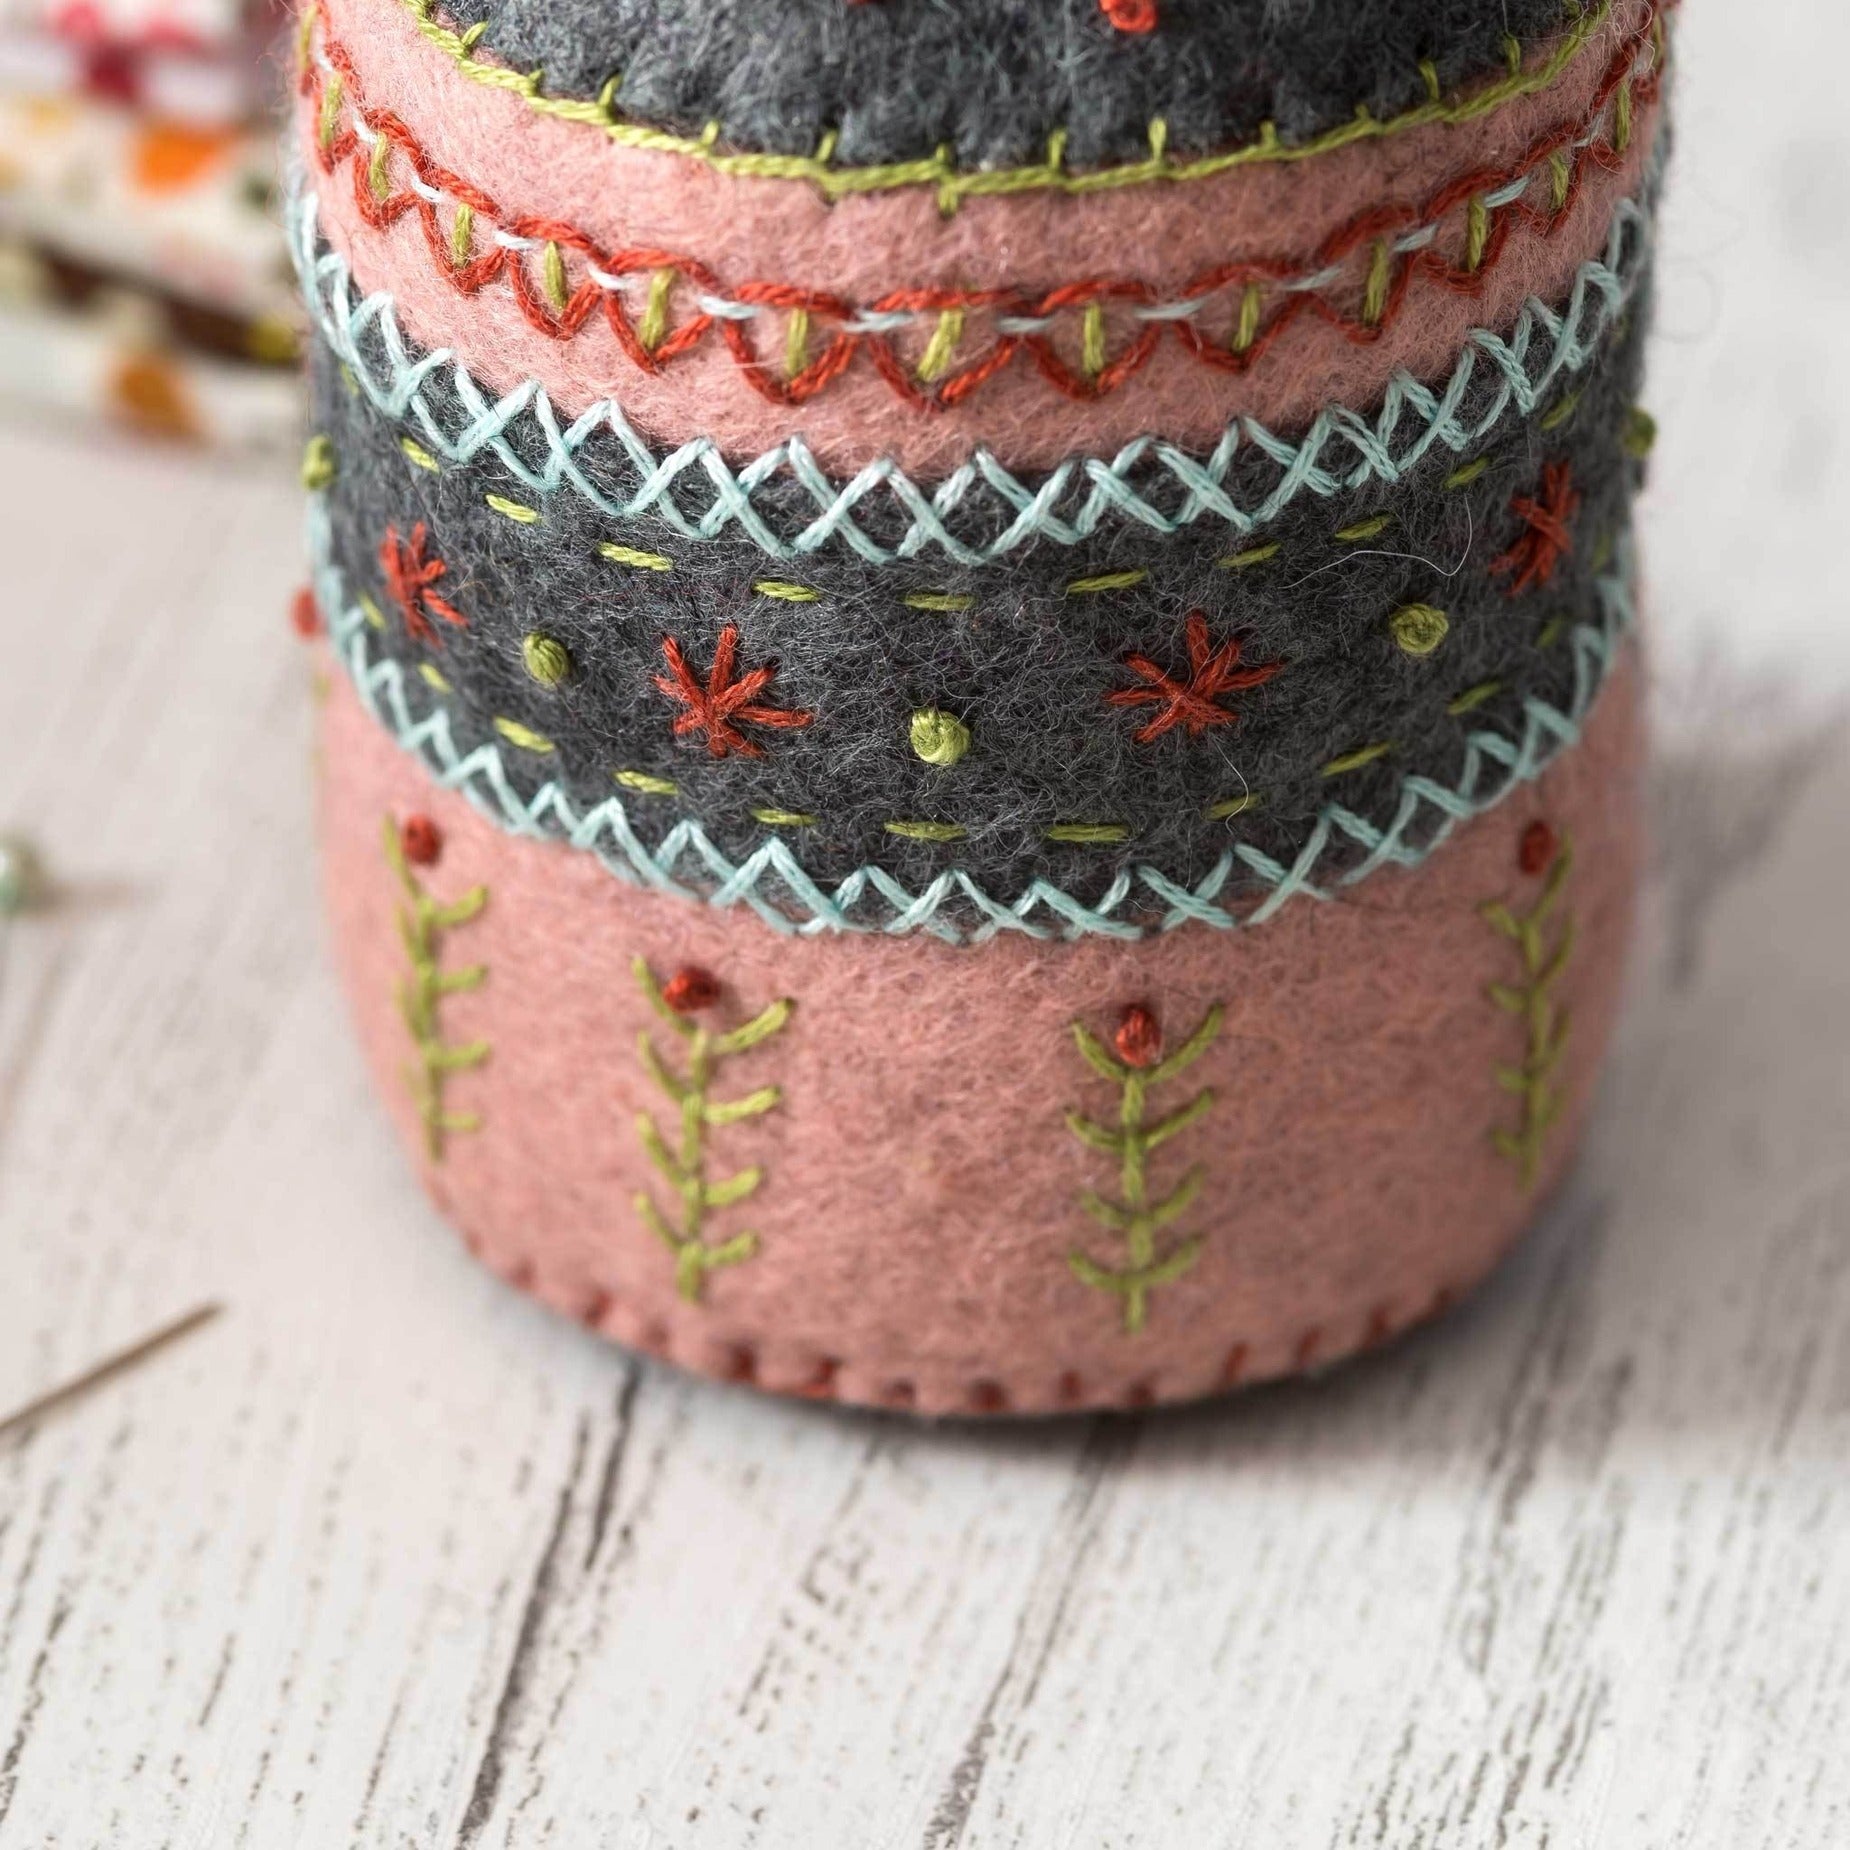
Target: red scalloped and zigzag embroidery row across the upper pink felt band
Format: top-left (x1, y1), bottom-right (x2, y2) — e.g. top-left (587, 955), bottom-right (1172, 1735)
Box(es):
top-left (300, 7), bottom-right (1661, 413)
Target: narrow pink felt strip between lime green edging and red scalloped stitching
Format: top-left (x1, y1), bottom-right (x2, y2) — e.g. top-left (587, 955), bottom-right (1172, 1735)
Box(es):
top-left (305, 0), bottom-right (1663, 302)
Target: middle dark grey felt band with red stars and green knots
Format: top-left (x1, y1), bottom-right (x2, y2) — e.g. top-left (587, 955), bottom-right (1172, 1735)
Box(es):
top-left (315, 290), bottom-right (1643, 917)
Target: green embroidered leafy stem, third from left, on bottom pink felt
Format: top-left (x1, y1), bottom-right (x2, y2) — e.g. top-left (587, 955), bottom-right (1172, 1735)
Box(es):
top-left (1066, 1003), bottom-right (1225, 1336)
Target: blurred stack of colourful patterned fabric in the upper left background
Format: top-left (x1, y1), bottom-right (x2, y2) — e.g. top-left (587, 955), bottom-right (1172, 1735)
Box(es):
top-left (0, 0), bottom-right (302, 450)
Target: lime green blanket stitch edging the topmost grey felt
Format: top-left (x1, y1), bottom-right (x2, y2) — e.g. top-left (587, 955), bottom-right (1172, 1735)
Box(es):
top-left (382, 0), bottom-right (1628, 215)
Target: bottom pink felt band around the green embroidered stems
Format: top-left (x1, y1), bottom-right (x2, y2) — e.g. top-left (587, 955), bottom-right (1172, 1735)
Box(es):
top-left (322, 643), bottom-right (1641, 1413)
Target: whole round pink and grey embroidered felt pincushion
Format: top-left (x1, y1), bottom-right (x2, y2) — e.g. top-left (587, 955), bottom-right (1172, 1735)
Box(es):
top-left (292, 0), bottom-right (1665, 1412)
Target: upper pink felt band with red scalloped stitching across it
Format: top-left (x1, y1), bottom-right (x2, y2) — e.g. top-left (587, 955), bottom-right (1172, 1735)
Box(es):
top-left (300, 0), bottom-right (1658, 477)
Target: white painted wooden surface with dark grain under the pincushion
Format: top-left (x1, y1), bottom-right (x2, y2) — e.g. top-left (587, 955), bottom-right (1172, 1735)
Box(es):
top-left (0, 0), bottom-right (1850, 1850)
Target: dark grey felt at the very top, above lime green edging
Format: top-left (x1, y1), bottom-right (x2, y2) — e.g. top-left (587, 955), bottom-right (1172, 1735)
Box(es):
top-left (432, 0), bottom-right (1576, 168)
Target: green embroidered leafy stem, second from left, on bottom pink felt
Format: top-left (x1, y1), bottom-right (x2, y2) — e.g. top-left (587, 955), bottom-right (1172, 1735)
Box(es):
top-left (631, 956), bottom-right (796, 1304)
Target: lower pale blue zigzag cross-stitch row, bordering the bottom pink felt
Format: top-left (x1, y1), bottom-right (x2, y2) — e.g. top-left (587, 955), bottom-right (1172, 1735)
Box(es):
top-left (309, 494), bottom-right (1632, 944)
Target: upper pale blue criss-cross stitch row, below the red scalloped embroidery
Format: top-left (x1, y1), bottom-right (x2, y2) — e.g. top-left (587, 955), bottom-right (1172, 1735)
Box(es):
top-left (289, 181), bottom-right (1652, 564)
